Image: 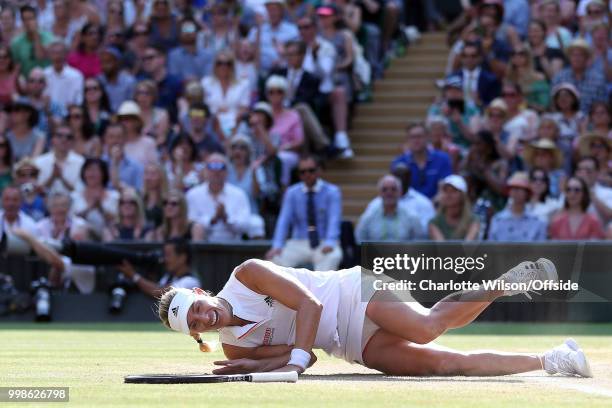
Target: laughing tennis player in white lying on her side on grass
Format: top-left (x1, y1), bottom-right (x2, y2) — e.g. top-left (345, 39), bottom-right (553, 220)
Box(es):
top-left (159, 258), bottom-right (592, 377)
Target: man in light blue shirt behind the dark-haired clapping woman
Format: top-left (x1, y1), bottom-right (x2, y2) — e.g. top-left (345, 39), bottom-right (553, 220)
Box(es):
top-left (102, 123), bottom-right (143, 191)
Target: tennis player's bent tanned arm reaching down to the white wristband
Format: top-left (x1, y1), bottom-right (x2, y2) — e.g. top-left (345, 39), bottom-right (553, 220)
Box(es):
top-left (236, 259), bottom-right (323, 372)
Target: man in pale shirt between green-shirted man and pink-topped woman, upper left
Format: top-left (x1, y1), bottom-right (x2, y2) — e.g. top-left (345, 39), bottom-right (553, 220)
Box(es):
top-left (44, 41), bottom-right (84, 108)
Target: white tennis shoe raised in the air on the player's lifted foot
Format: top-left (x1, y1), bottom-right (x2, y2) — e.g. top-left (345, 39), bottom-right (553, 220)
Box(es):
top-left (499, 258), bottom-right (559, 299)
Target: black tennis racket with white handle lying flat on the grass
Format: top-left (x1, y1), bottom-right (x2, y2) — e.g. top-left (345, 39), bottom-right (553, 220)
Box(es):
top-left (124, 371), bottom-right (298, 384)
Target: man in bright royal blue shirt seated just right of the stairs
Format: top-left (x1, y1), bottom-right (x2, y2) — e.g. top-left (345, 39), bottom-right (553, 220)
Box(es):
top-left (391, 123), bottom-right (452, 199)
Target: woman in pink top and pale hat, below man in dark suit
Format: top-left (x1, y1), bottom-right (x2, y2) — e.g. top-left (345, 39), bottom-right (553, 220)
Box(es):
top-left (266, 75), bottom-right (304, 185)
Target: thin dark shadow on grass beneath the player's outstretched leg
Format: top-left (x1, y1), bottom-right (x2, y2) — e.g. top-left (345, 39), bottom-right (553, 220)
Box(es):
top-left (300, 374), bottom-right (525, 384)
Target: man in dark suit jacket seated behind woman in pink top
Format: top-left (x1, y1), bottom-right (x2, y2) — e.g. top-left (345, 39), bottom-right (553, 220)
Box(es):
top-left (262, 40), bottom-right (330, 151)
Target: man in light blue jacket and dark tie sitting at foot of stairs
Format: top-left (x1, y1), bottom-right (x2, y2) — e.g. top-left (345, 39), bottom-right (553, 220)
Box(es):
top-left (266, 156), bottom-right (342, 271)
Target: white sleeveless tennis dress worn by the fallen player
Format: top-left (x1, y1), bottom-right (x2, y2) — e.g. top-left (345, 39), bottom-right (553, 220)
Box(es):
top-left (217, 261), bottom-right (378, 364)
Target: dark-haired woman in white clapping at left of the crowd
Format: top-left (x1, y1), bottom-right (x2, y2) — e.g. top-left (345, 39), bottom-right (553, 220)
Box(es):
top-left (72, 158), bottom-right (119, 239)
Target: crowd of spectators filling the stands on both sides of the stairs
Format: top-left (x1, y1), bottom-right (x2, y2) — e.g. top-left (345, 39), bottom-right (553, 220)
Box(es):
top-left (0, 0), bottom-right (612, 286)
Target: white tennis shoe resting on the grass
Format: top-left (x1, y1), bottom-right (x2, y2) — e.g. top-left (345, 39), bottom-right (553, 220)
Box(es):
top-left (544, 339), bottom-right (593, 378)
